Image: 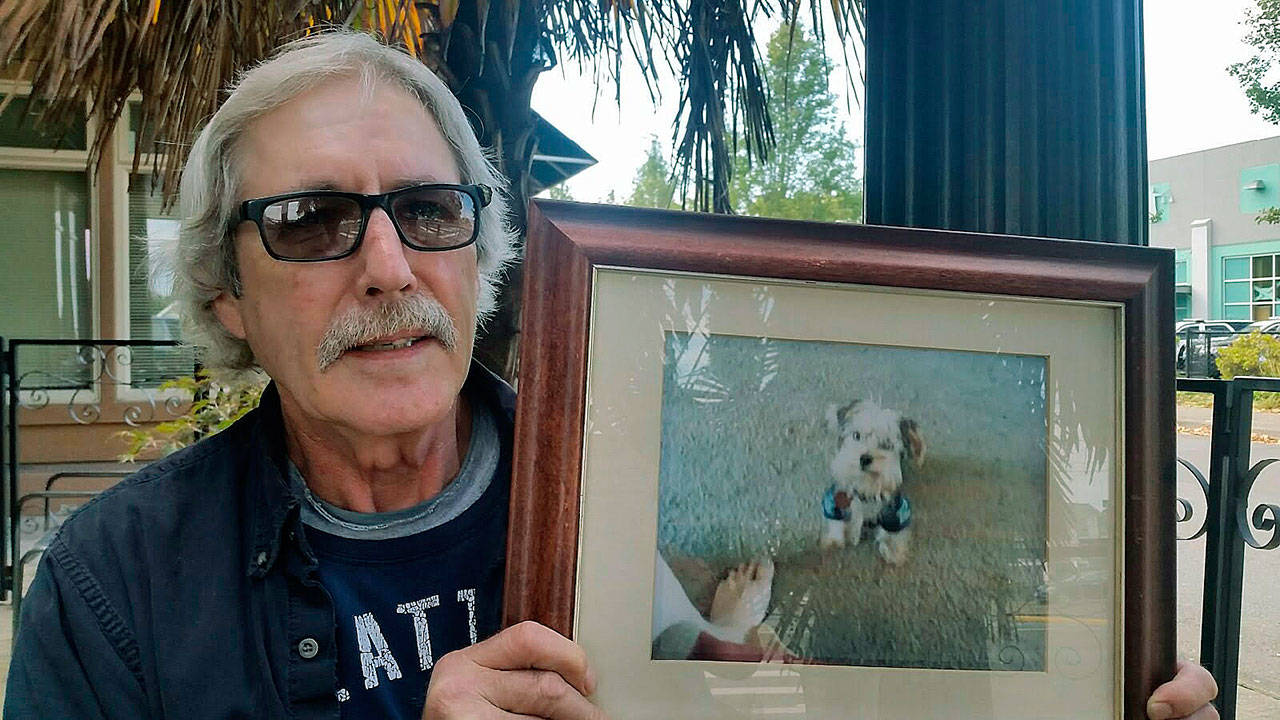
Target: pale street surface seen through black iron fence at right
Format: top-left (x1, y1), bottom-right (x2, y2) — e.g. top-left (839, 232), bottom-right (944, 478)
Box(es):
top-left (1178, 433), bottom-right (1280, 720)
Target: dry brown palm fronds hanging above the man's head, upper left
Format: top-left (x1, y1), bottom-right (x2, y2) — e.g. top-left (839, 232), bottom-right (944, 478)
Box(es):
top-left (0, 0), bottom-right (430, 203)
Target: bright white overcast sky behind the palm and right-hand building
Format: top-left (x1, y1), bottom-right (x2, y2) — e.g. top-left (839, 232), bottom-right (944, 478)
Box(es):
top-left (534, 0), bottom-right (1280, 200)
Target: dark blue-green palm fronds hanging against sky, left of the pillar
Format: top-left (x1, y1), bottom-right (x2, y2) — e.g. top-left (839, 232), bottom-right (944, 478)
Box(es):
top-left (547, 0), bottom-right (865, 213)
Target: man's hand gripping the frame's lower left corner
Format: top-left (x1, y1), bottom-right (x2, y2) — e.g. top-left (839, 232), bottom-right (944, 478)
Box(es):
top-left (422, 621), bottom-right (605, 720)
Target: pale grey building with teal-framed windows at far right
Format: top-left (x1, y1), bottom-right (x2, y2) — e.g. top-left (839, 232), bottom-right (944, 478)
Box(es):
top-left (1148, 136), bottom-right (1280, 322)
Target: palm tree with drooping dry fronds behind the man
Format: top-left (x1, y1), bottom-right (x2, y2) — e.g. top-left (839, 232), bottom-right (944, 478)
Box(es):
top-left (0, 0), bottom-right (865, 368)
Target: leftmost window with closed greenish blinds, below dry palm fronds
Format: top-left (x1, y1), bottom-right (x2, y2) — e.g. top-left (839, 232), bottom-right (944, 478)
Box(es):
top-left (0, 96), bottom-right (95, 388)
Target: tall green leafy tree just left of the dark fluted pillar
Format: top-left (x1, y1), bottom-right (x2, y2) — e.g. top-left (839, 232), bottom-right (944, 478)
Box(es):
top-left (730, 24), bottom-right (863, 220)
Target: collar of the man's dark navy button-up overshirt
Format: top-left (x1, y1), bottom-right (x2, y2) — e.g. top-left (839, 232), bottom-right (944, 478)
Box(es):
top-left (237, 361), bottom-right (516, 578)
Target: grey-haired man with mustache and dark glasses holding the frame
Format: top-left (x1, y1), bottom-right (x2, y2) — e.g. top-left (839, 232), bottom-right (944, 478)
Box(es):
top-left (5, 33), bottom-right (1211, 720)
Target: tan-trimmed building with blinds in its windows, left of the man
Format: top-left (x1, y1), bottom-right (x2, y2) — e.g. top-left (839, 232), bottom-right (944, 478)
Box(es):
top-left (0, 89), bottom-right (192, 462)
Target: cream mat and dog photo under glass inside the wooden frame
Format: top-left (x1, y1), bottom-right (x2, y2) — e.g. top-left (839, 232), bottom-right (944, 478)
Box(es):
top-left (576, 265), bottom-right (1121, 719)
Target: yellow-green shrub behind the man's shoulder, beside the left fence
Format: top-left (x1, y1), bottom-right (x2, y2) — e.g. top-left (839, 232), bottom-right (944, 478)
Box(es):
top-left (120, 370), bottom-right (268, 462)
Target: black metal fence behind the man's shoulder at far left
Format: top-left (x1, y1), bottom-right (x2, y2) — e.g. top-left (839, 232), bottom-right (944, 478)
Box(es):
top-left (0, 337), bottom-right (198, 601)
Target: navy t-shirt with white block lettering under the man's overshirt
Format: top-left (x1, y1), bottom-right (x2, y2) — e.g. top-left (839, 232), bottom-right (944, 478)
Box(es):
top-left (306, 371), bottom-right (511, 720)
